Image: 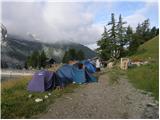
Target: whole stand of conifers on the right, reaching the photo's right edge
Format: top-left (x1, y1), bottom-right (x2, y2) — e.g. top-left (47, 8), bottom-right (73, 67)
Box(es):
top-left (97, 13), bottom-right (159, 60)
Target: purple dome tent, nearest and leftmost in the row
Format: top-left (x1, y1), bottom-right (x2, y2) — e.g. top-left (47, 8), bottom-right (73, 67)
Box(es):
top-left (27, 70), bottom-right (55, 92)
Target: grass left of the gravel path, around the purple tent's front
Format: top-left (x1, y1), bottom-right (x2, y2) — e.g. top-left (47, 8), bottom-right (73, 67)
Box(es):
top-left (1, 77), bottom-right (78, 119)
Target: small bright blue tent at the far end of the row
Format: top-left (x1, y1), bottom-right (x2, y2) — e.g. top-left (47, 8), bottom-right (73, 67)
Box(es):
top-left (82, 60), bottom-right (96, 73)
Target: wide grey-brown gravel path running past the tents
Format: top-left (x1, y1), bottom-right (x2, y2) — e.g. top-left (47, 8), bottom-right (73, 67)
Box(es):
top-left (38, 72), bottom-right (159, 119)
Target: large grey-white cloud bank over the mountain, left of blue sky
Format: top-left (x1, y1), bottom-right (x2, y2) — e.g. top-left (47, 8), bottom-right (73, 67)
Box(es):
top-left (2, 2), bottom-right (103, 45)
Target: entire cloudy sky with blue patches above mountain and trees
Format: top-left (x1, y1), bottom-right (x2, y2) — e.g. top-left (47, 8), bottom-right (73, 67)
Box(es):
top-left (1, 0), bottom-right (158, 49)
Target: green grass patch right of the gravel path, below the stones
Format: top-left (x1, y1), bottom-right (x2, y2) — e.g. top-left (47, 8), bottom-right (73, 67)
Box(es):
top-left (127, 64), bottom-right (159, 100)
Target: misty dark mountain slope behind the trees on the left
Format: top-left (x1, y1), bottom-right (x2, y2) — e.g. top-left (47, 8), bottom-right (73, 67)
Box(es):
top-left (1, 35), bottom-right (96, 67)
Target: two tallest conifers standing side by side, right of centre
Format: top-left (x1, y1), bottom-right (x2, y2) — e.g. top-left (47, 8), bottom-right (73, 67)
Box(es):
top-left (97, 13), bottom-right (127, 60)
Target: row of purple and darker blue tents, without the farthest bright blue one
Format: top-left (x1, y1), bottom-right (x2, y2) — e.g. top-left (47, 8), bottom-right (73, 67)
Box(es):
top-left (27, 64), bottom-right (97, 92)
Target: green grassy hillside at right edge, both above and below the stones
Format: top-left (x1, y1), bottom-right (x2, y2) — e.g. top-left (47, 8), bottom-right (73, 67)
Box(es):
top-left (127, 36), bottom-right (159, 99)
